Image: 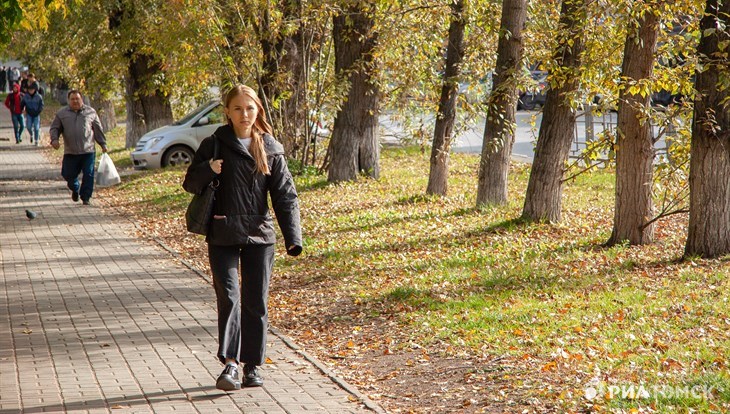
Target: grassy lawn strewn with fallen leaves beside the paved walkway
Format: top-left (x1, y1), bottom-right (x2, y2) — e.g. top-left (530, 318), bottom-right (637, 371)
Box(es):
top-left (100, 149), bottom-right (730, 413)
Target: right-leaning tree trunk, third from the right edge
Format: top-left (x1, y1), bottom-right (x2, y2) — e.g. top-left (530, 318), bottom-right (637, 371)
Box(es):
top-left (522, 0), bottom-right (586, 223)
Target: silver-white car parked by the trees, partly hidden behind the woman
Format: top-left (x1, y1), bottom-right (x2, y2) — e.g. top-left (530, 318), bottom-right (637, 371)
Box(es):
top-left (132, 100), bottom-right (225, 169)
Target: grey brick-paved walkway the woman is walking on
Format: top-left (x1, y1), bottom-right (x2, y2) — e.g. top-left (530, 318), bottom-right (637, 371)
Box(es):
top-left (0, 123), bottom-right (382, 414)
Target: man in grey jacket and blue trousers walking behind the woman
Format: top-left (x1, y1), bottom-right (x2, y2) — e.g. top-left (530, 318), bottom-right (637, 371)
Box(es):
top-left (51, 89), bottom-right (106, 205)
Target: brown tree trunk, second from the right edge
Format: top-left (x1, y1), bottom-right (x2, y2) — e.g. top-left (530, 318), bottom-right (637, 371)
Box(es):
top-left (606, 8), bottom-right (659, 246)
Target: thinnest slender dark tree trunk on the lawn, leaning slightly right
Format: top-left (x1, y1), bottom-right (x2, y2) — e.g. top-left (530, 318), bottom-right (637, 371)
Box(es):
top-left (426, 0), bottom-right (466, 195)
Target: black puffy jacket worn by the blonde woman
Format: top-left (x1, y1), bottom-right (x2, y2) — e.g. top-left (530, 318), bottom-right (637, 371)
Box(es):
top-left (183, 125), bottom-right (302, 256)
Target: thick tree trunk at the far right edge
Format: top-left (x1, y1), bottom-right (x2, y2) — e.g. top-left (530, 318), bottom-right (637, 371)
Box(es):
top-left (684, 0), bottom-right (730, 258)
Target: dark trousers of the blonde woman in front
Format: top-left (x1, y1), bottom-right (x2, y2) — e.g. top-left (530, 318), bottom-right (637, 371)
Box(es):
top-left (208, 244), bottom-right (274, 365)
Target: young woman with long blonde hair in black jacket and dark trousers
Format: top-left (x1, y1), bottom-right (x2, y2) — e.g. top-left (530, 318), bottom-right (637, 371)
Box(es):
top-left (183, 85), bottom-right (302, 391)
